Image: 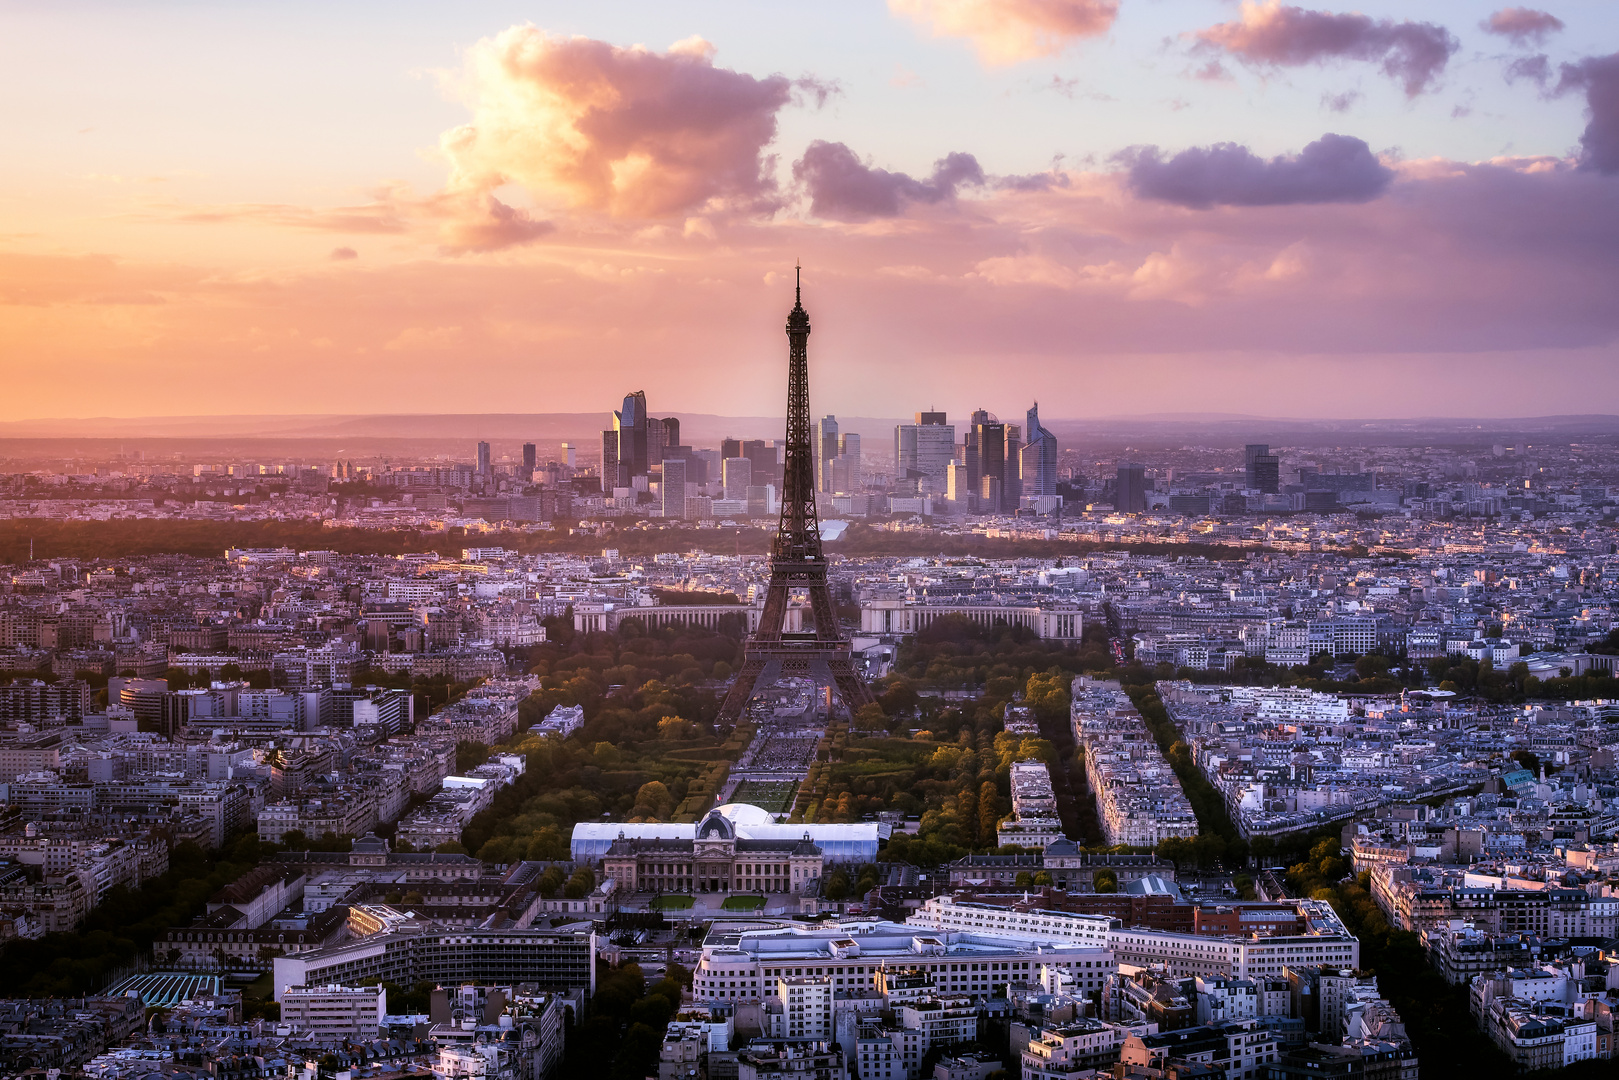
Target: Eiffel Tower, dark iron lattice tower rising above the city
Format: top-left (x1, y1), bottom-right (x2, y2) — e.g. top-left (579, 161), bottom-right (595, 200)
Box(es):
top-left (719, 267), bottom-right (876, 724)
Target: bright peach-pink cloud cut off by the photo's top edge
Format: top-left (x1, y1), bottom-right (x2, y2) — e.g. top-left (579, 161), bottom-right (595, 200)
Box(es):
top-left (889, 0), bottom-right (1119, 65)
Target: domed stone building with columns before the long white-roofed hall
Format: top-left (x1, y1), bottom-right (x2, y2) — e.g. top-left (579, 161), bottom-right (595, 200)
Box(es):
top-left (602, 806), bottom-right (822, 895)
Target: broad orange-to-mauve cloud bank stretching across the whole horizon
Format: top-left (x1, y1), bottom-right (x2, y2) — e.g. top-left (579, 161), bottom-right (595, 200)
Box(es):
top-left (9, 158), bottom-right (1619, 424)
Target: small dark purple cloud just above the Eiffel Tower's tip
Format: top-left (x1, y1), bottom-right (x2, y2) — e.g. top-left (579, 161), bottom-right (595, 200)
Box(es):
top-left (793, 139), bottom-right (984, 222)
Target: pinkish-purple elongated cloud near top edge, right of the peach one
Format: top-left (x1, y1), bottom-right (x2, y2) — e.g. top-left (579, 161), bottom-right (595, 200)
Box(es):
top-left (1196, 0), bottom-right (1460, 97)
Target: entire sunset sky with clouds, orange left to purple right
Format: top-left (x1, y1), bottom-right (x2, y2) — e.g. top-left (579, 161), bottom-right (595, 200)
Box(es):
top-left (0, 0), bottom-right (1619, 421)
